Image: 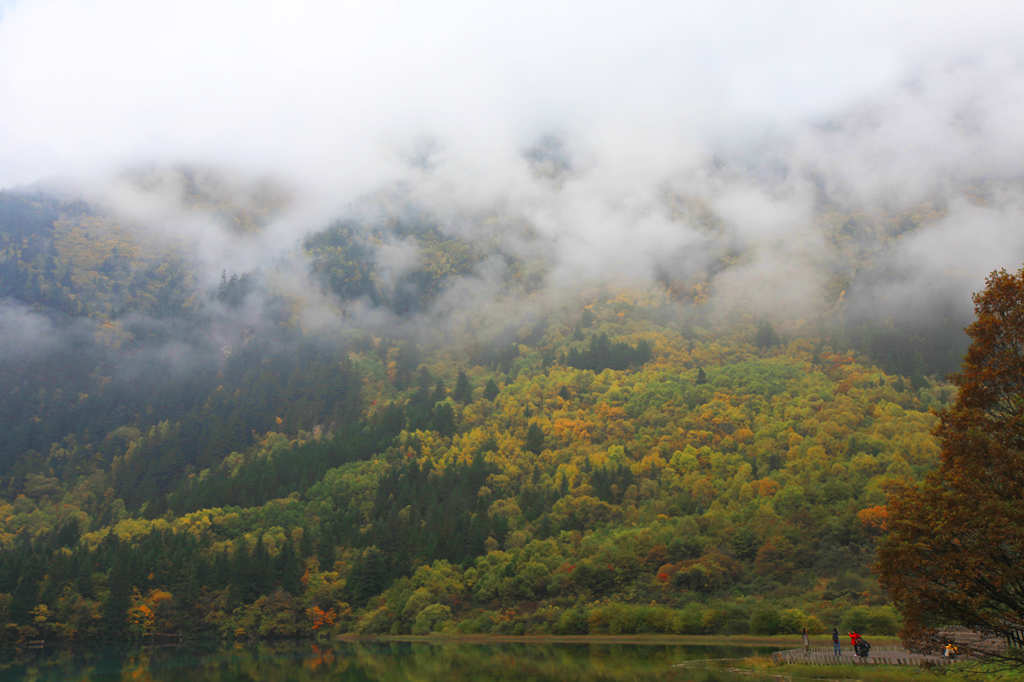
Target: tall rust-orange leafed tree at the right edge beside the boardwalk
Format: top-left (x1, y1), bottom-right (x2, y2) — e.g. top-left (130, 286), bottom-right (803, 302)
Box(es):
top-left (878, 268), bottom-right (1024, 667)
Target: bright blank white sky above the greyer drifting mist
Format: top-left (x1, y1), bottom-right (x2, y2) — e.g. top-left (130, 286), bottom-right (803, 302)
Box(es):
top-left (0, 0), bottom-right (1024, 185)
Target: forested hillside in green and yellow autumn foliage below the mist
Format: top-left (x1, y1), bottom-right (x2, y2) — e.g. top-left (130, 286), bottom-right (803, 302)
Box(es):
top-left (0, 188), bottom-right (950, 640)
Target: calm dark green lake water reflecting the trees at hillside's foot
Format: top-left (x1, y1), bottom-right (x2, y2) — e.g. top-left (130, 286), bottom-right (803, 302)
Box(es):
top-left (0, 642), bottom-right (772, 682)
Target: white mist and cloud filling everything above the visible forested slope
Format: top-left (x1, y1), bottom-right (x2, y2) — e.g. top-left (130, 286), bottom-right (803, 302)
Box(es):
top-left (0, 0), bottom-right (1024, 333)
